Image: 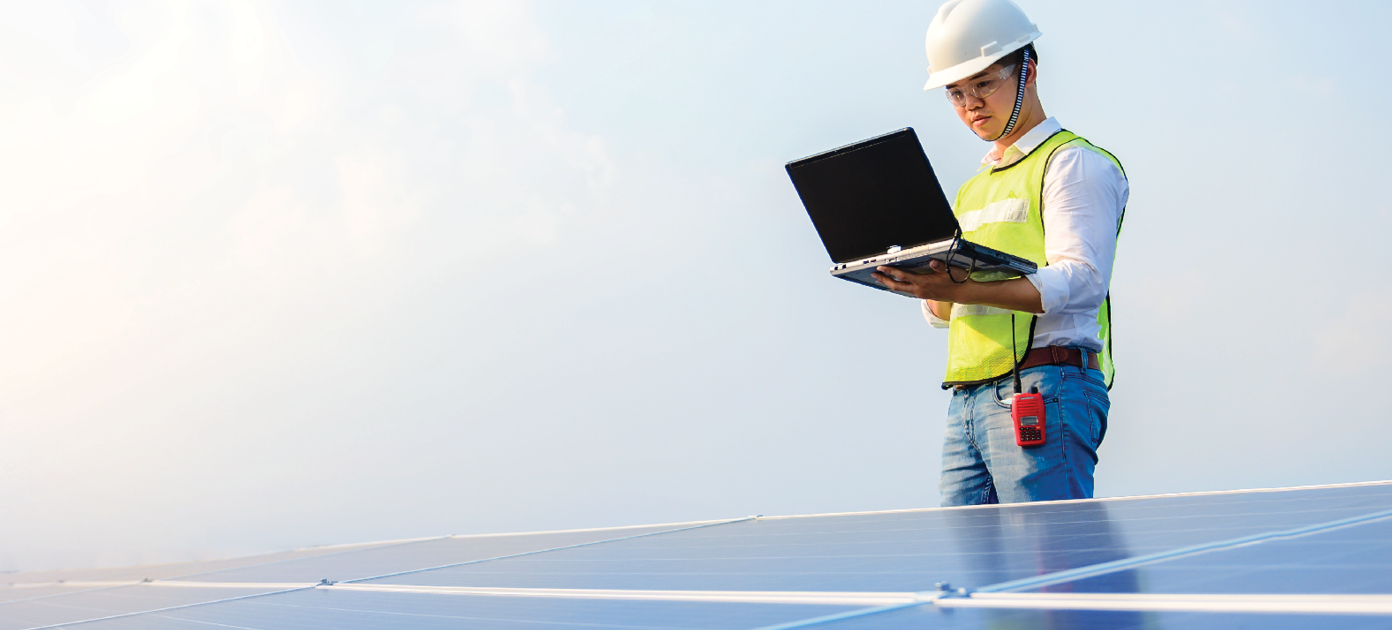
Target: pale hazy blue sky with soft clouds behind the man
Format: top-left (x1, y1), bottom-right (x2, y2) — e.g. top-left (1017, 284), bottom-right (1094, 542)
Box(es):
top-left (0, 0), bottom-right (1392, 570)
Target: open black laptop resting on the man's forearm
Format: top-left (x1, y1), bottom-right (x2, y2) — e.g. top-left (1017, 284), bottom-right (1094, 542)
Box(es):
top-left (786, 128), bottom-right (1038, 298)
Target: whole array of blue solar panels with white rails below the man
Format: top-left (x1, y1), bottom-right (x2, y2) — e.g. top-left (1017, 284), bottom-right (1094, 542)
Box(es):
top-left (0, 483), bottom-right (1392, 630)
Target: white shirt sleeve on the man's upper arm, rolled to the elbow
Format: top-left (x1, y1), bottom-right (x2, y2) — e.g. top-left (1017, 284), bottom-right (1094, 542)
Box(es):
top-left (1024, 146), bottom-right (1130, 314)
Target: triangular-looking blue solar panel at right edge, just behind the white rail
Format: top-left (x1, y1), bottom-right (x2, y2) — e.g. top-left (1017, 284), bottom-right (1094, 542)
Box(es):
top-left (1024, 519), bottom-right (1392, 595)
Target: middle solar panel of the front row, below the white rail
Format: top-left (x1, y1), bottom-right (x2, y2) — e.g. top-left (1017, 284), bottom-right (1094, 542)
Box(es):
top-left (43, 590), bottom-right (853, 630)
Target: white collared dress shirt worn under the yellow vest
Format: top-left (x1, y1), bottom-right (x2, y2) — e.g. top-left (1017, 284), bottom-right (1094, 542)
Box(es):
top-left (923, 118), bottom-right (1130, 352)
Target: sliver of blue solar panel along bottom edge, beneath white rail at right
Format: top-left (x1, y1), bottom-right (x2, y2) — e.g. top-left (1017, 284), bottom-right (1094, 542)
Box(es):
top-left (813, 598), bottom-right (1392, 630)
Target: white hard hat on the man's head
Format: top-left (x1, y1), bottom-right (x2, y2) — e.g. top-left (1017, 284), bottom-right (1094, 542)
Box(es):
top-left (923, 0), bottom-right (1040, 90)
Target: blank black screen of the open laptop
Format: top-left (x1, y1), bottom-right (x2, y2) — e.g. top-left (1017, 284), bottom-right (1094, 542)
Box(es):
top-left (786, 129), bottom-right (958, 263)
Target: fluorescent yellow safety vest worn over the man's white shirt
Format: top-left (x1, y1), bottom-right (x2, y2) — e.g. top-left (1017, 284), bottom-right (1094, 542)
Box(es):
top-left (942, 131), bottom-right (1126, 388)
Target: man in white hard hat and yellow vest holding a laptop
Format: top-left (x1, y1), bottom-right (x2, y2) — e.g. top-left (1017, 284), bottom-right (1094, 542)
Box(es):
top-left (876, 0), bottom-right (1130, 506)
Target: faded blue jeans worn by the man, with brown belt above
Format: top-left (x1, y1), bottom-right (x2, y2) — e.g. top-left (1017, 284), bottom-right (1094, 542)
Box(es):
top-left (938, 358), bottom-right (1111, 506)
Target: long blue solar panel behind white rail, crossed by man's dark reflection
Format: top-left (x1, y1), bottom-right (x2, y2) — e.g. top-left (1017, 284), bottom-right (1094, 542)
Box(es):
top-left (364, 485), bottom-right (1392, 592)
